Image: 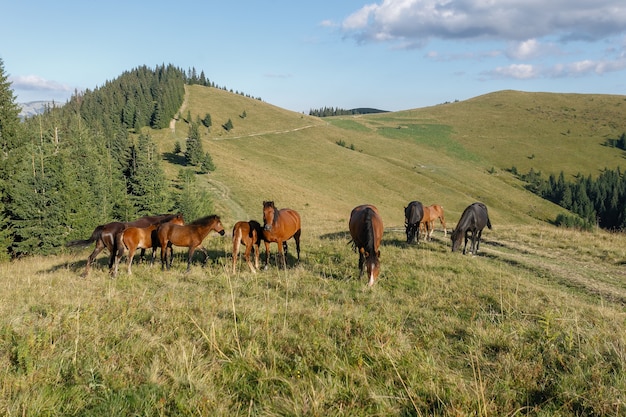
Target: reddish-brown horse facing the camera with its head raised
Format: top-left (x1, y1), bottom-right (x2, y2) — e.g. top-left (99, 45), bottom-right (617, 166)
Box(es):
top-left (263, 201), bottom-right (302, 269)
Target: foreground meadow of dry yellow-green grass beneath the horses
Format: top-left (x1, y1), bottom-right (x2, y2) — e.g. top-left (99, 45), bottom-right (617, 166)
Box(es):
top-left (0, 226), bottom-right (626, 416)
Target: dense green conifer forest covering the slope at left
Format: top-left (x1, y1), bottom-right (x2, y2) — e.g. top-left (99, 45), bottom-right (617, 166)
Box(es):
top-left (0, 59), bottom-right (214, 259)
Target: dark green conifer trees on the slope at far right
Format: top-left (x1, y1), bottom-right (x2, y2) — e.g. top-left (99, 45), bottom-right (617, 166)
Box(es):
top-left (511, 164), bottom-right (626, 230)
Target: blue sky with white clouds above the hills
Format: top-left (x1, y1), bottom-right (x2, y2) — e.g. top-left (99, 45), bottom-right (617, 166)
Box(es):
top-left (0, 0), bottom-right (626, 113)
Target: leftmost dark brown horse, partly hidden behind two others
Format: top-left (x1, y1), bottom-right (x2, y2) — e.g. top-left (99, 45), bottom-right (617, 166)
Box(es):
top-left (65, 213), bottom-right (185, 278)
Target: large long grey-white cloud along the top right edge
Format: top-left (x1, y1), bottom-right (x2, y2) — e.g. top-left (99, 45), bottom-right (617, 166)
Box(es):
top-left (342, 0), bottom-right (626, 46)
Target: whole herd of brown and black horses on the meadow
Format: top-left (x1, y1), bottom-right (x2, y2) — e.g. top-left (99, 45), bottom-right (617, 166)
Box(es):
top-left (66, 201), bottom-right (491, 286)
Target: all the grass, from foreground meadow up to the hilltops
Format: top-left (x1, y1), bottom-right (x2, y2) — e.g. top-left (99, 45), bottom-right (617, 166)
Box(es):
top-left (0, 86), bottom-right (626, 416)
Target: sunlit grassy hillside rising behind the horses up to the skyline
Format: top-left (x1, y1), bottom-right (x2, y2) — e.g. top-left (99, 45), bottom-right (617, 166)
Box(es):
top-left (155, 86), bottom-right (626, 233)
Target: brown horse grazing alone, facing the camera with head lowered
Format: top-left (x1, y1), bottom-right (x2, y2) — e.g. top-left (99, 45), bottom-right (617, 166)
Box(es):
top-left (348, 204), bottom-right (383, 287)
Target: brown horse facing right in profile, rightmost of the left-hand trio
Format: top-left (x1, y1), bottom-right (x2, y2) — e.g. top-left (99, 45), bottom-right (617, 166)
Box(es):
top-left (157, 214), bottom-right (225, 272)
